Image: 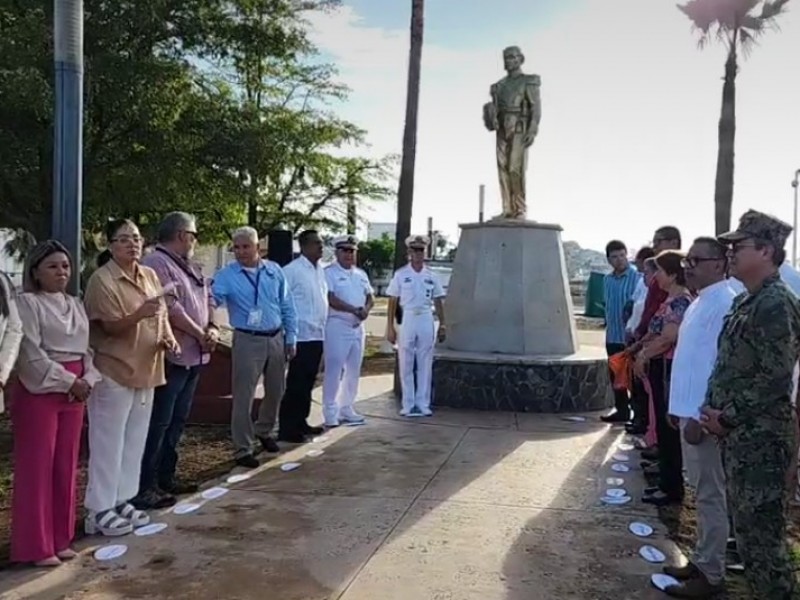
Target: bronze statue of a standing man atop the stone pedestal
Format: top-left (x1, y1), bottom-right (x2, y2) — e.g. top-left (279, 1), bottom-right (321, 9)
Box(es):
top-left (483, 46), bottom-right (542, 219)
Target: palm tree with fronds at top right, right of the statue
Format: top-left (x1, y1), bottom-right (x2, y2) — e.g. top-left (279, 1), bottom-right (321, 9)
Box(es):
top-left (678, 0), bottom-right (789, 235)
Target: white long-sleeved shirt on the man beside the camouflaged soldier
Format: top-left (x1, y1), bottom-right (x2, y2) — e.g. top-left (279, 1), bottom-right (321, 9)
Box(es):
top-left (669, 280), bottom-right (737, 420)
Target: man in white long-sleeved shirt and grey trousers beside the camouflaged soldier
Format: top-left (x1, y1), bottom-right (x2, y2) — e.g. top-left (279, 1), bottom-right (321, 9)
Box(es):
top-left (664, 237), bottom-right (737, 598)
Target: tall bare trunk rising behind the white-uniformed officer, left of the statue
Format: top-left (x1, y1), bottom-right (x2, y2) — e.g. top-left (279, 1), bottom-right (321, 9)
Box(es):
top-left (394, 0), bottom-right (425, 269)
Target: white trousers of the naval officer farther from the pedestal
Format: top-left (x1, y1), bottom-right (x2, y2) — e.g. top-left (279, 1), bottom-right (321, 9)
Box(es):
top-left (322, 319), bottom-right (366, 425)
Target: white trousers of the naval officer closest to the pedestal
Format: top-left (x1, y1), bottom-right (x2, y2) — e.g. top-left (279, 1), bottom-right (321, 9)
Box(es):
top-left (397, 310), bottom-right (436, 411)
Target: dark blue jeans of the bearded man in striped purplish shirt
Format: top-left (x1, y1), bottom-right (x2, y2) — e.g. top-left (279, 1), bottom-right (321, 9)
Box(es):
top-left (139, 362), bottom-right (200, 493)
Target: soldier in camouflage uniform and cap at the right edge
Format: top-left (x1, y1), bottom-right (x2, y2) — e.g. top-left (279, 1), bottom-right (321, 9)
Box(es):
top-left (703, 210), bottom-right (800, 600)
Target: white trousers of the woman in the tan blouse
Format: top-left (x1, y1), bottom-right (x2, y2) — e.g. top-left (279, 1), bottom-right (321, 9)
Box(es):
top-left (85, 375), bottom-right (153, 512)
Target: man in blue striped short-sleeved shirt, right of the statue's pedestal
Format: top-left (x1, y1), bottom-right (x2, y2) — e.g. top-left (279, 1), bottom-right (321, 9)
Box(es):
top-left (601, 240), bottom-right (641, 423)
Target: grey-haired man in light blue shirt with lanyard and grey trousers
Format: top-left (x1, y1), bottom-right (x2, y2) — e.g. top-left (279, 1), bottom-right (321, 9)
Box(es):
top-left (211, 227), bottom-right (297, 469)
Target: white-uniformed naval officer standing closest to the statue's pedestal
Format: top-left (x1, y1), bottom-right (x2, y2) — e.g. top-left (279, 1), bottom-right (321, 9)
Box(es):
top-left (386, 235), bottom-right (445, 417)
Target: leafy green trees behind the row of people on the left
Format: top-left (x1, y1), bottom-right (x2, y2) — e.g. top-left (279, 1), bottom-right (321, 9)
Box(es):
top-left (0, 0), bottom-right (393, 255)
